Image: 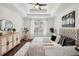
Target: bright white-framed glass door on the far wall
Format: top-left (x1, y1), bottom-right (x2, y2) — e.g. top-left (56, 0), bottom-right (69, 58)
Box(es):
top-left (31, 20), bottom-right (47, 37)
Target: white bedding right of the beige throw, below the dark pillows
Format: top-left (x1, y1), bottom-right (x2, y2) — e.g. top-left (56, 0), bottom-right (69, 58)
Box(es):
top-left (44, 46), bottom-right (79, 56)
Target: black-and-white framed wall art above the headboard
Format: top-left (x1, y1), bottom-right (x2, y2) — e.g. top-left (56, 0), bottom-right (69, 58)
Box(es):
top-left (62, 11), bottom-right (75, 27)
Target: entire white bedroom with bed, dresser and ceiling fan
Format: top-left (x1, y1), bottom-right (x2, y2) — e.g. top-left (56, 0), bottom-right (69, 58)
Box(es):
top-left (0, 3), bottom-right (79, 56)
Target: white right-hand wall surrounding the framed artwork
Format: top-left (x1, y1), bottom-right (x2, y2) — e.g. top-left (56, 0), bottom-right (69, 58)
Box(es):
top-left (55, 4), bottom-right (79, 33)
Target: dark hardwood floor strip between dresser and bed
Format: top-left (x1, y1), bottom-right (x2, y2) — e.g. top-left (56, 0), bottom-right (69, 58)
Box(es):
top-left (3, 40), bottom-right (31, 56)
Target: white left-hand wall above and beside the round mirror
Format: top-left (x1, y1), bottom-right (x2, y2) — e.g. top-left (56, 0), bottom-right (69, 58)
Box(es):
top-left (0, 5), bottom-right (23, 39)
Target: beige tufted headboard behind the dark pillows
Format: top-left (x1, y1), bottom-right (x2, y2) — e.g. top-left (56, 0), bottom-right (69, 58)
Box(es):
top-left (59, 28), bottom-right (79, 45)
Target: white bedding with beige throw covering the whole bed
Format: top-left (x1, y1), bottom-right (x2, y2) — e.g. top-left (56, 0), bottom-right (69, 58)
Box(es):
top-left (16, 37), bottom-right (79, 56)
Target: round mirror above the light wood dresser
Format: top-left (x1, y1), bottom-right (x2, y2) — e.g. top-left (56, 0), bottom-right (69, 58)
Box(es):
top-left (0, 19), bottom-right (13, 31)
